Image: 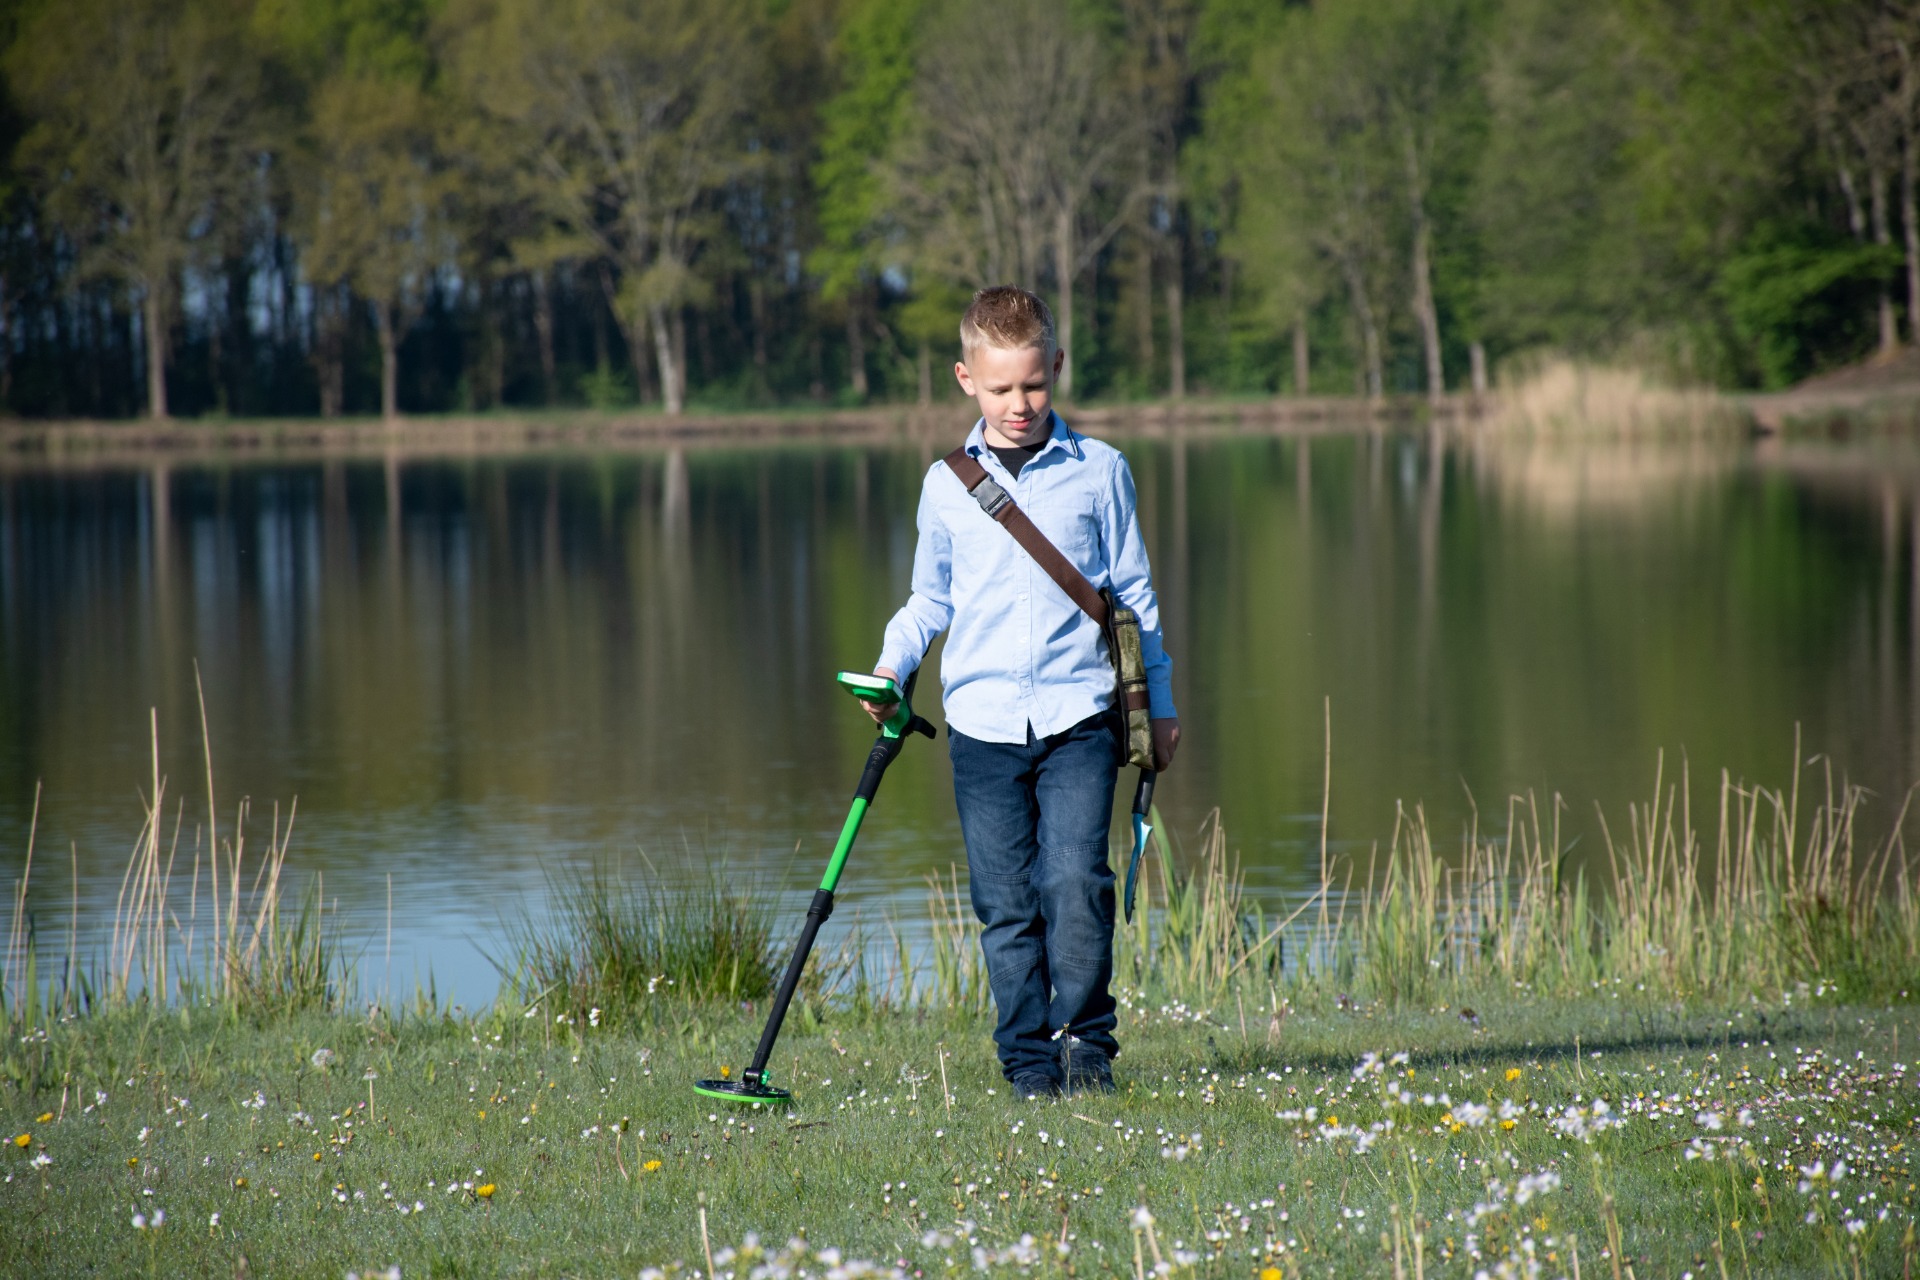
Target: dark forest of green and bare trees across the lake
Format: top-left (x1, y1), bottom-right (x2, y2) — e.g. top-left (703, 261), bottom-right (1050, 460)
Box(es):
top-left (0, 0), bottom-right (1920, 416)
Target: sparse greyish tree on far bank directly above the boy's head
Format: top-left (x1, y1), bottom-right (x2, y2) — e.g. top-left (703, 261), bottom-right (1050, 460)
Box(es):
top-left (891, 0), bottom-right (1142, 395)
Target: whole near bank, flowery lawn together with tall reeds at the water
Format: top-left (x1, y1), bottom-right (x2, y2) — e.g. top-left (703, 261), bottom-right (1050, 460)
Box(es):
top-left (0, 717), bottom-right (1920, 1280)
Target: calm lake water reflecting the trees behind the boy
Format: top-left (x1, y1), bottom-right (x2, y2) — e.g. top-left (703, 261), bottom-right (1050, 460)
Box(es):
top-left (0, 428), bottom-right (1920, 1006)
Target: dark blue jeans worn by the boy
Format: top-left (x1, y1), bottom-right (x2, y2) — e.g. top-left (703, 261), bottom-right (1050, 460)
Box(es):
top-left (948, 712), bottom-right (1119, 1080)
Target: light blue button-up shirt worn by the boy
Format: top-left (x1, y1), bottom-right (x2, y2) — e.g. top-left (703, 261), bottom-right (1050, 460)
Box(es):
top-left (877, 415), bottom-right (1175, 743)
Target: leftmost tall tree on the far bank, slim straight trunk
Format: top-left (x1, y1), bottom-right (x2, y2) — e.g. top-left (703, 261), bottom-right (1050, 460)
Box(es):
top-left (6, 0), bottom-right (259, 418)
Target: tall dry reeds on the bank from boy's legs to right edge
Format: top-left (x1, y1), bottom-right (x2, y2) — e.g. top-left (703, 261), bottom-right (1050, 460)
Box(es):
top-left (918, 745), bottom-right (1920, 1009)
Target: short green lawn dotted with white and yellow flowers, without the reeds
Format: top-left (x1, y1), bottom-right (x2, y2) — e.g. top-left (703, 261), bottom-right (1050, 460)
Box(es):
top-left (0, 992), bottom-right (1920, 1280)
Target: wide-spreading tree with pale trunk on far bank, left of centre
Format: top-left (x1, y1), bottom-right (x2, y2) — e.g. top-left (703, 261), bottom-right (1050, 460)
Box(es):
top-left (447, 0), bottom-right (758, 415)
